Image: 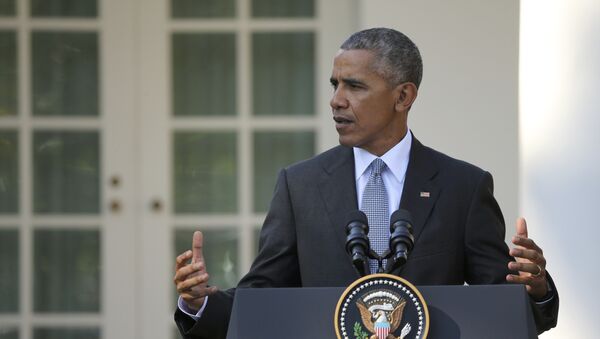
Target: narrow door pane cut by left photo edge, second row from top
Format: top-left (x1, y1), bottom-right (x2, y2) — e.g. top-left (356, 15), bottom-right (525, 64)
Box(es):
top-left (0, 31), bottom-right (17, 117)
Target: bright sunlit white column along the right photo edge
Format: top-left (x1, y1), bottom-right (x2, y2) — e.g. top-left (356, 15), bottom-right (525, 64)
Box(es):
top-left (520, 0), bottom-right (600, 338)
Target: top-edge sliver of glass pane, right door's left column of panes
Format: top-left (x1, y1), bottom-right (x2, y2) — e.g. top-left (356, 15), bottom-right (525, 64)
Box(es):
top-left (171, 0), bottom-right (235, 18)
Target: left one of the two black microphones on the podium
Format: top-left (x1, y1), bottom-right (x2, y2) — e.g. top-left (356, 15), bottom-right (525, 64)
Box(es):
top-left (346, 210), bottom-right (370, 277)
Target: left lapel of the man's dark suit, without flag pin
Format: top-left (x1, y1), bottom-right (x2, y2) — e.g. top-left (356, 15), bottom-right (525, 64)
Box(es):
top-left (319, 146), bottom-right (358, 255)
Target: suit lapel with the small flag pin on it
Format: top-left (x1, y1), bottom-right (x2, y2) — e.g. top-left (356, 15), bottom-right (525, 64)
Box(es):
top-left (400, 137), bottom-right (440, 248)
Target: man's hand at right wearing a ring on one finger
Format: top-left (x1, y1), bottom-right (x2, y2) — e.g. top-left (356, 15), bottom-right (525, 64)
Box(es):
top-left (506, 218), bottom-right (548, 300)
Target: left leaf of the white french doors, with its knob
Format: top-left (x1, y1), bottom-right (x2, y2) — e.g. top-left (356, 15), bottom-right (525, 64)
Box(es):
top-left (0, 0), bottom-right (138, 339)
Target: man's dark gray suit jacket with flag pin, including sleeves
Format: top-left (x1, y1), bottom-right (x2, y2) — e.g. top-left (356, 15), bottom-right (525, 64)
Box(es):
top-left (175, 138), bottom-right (558, 339)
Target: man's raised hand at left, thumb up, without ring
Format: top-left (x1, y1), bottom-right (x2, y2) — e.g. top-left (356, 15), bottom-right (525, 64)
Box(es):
top-left (173, 231), bottom-right (217, 312)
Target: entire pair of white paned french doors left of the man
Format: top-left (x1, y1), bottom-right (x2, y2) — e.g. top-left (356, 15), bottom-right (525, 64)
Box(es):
top-left (0, 0), bottom-right (356, 339)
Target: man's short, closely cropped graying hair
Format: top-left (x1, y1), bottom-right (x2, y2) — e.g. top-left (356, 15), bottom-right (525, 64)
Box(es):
top-left (340, 28), bottom-right (423, 88)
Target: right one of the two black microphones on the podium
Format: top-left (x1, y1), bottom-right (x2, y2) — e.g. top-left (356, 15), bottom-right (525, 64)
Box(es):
top-left (388, 210), bottom-right (415, 272)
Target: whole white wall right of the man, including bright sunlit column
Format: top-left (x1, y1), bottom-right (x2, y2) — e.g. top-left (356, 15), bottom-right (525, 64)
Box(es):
top-left (358, 0), bottom-right (600, 338)
